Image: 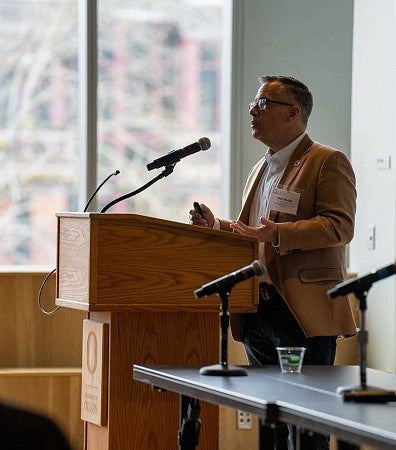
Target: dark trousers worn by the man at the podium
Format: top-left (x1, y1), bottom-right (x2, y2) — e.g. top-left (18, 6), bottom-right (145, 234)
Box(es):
top-left (244, 285), bottom-right (337, 450)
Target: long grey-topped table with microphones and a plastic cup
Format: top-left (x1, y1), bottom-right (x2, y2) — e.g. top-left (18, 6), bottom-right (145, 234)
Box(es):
top-left (133, 365), bottom-right (396, 450)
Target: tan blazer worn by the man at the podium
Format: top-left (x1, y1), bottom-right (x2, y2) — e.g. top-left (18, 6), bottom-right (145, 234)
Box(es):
top-left (220, 135), bottom-right (356, 340)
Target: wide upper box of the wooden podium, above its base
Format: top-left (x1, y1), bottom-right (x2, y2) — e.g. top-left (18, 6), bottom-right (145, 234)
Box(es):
top-left (57, 213), bottom-right (258, 311)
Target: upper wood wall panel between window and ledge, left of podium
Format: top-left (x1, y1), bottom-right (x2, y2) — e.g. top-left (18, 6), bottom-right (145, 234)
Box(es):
top-left (0, 272), bottom-right (85, 367)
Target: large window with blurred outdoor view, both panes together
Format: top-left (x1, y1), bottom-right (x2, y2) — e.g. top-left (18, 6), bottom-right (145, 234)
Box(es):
top-left (0, 0), bottom-right (223, 264)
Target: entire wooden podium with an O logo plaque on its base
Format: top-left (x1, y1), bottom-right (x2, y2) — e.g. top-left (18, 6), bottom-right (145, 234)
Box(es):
top-left (56, 213), bottom-right (258, 450)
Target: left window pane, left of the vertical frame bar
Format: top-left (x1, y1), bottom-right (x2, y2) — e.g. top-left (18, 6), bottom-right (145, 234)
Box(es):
top-left (0, 0), bottom-right (78, 264)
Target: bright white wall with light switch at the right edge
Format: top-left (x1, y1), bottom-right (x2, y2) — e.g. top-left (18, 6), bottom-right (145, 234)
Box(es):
top-left (350, 0), bottom-right (396, 372)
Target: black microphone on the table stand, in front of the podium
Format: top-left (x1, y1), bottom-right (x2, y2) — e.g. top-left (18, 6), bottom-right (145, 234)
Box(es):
top-left (194, 260), bottom-right (265, 298)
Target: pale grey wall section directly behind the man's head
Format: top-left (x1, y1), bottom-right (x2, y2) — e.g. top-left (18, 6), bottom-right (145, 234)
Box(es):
top-left (223, 0), bottom-right (353, 217)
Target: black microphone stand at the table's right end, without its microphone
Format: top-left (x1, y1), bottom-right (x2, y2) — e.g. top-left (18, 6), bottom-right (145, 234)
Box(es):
top-left (337, 285), bottom-right (396, 403)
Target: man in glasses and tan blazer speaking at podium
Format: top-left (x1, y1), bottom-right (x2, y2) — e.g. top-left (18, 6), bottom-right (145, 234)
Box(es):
top-left (190, 76), bottom-right (356, 450)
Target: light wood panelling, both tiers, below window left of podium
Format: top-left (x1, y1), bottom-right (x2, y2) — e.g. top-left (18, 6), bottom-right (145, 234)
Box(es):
top-left (0, 271), bottom-right (85, 450)
